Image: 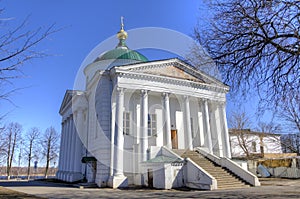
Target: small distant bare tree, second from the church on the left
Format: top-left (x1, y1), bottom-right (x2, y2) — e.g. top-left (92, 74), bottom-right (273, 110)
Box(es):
top-left (26, 127), bottom-right (40, 179)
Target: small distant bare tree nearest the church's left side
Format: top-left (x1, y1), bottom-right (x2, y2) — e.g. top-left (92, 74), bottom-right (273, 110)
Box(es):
top-left (41, 127), bottom-right (59, 178)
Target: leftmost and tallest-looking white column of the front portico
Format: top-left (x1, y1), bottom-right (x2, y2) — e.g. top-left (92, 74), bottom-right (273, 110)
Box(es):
top-left (114, 88), bottom-right (124, 176)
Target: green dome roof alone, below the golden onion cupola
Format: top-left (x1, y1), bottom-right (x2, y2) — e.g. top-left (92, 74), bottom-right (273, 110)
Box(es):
top-left (95, 46), bottom-right (148, 62)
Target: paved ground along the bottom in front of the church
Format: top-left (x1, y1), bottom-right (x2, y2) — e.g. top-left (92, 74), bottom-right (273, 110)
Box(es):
top-left (0, 179), bottom-right (300, 199)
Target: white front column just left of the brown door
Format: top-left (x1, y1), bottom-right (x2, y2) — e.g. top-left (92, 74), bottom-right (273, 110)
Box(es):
top-left (162, 93), bottom-right (172, 149)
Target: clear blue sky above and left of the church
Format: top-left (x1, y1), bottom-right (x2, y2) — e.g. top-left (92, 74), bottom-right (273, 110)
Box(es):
top-left (0, 0), bottom-right (209, 131)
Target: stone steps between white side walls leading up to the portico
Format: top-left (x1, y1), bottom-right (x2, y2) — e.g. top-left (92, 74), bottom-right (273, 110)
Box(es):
top-left (173, 149), bottom-right (250, 189)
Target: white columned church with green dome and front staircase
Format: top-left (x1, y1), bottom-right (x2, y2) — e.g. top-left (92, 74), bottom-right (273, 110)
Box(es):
top-left (57, 21), bottom-right (259, 190)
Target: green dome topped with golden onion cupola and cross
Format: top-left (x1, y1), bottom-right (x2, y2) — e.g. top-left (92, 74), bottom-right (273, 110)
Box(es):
top-left (94, 18), bottom-right (148, 62)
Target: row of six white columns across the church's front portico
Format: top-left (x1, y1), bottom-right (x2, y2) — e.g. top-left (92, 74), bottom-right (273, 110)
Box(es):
top-left (111, 88), bottom-right (230, 180)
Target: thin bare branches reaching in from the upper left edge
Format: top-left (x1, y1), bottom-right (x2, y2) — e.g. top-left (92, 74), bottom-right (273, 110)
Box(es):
top-left (0, 9), bottom-right (58, 104)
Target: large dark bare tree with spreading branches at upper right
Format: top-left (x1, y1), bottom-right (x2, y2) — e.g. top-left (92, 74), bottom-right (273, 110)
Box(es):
top-left (195, 0), bottom-right (300, 108)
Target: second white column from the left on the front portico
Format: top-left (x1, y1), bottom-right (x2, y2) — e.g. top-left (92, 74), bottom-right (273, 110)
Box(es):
top-left (140, 90), bottom-right (148, 161)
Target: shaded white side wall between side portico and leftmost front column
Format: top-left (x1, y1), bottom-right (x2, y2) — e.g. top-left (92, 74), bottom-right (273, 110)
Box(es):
top-left (88, 72), bottom-right (112, 183)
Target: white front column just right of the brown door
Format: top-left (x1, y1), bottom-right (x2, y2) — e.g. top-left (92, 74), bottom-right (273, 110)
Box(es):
top-left (184, 96), bottom-right (194, 150)
